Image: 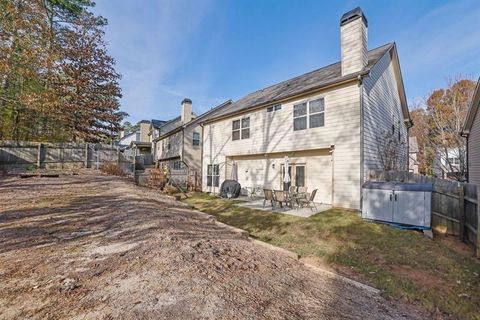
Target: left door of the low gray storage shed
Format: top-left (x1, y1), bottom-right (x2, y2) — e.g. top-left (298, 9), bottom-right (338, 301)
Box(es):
top-left (362, 189), bottom-right (393, 222)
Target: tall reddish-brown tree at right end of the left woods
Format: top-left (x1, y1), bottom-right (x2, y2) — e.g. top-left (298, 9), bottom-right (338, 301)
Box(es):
top-left (61, 13), bottom-right (122, 142)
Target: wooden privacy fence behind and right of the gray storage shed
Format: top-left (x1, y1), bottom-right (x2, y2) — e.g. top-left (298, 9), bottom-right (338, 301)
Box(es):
top-left (369, 171), bottom-right (480, 257)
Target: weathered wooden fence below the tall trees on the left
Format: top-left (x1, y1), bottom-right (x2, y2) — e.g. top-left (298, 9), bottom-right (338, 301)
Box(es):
top-left (0, 141), bottom-right (135, 173)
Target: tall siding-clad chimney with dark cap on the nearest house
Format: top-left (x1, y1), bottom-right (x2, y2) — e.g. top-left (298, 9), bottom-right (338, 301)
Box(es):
top-left (340, 7), bottom-right (368, 76)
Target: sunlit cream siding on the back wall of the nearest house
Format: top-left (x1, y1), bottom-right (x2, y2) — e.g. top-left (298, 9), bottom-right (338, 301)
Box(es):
top-left (202, 83), bottom-right (360, 209)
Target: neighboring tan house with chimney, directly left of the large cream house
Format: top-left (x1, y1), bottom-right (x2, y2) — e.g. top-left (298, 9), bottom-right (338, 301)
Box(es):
top-left (153, 98), bottom-right (231, 186)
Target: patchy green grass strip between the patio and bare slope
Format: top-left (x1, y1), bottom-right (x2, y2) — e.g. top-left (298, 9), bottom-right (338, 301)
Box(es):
top-left (185, 193), bottom-right (480, 319)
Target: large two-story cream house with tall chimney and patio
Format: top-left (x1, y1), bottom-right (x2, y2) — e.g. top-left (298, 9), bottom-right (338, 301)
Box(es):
top-left (202, 8), bottom-right (411, 209)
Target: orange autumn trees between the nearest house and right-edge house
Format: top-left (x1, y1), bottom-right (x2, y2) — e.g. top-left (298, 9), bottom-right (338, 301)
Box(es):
top-left (410, 76), bottom-right (476, 181)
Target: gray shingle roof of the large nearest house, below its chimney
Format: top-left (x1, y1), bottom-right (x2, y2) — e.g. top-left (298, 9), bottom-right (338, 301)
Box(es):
top-left (202, 43), bottom-right (394, 119)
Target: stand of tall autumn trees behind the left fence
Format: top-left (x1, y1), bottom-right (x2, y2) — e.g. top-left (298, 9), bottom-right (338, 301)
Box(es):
top-left (0, 0), bottom-right (127, 142)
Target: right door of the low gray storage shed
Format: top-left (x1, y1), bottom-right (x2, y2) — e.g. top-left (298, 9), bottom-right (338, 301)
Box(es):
top-left (393, 191), bottom-right (425, 226)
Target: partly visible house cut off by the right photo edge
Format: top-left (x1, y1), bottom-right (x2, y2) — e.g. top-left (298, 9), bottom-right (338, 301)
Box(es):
top-left (462, 78), bottom-right (480, 186)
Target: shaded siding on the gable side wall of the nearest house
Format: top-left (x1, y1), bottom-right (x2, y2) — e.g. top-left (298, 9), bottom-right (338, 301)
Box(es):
top-left (363, 53), bottom-right (408, 179)
